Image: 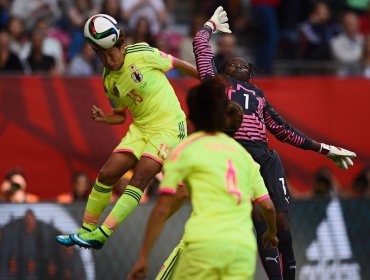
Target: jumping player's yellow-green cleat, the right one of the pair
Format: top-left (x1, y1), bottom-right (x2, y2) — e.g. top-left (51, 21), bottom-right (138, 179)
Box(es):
top-left (70, 227), bottom-right (109, 250)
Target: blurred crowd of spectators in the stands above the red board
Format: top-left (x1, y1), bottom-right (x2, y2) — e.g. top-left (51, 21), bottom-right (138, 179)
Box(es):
top-left (0, 0), bottom-right (370, 78)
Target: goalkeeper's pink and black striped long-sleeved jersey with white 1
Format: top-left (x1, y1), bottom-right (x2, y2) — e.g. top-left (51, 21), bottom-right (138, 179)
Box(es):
top-left (193, 27), bottom-right (312, 149)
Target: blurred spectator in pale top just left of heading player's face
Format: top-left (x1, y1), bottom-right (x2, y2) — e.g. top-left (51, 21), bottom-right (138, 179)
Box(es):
top-left (67, 42), bottom-right (101, 76)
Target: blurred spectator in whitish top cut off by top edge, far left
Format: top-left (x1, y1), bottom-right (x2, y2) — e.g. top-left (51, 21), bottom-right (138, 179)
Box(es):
top-left (10, 0), bottom-right (61, 32)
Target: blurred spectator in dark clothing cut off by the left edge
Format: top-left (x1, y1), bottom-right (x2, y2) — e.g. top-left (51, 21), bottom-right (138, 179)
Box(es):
top-left (0, 30), bottom-right (24, 73)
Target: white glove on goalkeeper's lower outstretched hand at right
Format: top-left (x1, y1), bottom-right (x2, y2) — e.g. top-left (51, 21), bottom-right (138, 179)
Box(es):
top-left (319, 143), bottom-right (356, 170)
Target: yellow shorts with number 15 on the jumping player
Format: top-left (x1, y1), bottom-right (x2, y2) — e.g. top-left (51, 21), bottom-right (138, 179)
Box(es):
top-left (113, 120), bottom-right (187, 164)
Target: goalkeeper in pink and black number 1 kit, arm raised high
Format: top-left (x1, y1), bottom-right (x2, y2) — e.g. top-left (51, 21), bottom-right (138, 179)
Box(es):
top-left (193, 7), bottom-right (356, 280)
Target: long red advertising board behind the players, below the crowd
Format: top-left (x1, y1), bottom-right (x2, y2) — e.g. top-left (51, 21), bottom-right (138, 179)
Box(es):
top-left (0, 77), bottom-right (370, 199)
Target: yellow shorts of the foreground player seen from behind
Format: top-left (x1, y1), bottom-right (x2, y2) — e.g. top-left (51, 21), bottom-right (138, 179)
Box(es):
top-left (171, 242), bottom-right (257, 280)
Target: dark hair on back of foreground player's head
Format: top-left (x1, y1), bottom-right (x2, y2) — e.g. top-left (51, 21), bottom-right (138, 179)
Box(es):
top-left (187, 76), bottom-right (228, 132)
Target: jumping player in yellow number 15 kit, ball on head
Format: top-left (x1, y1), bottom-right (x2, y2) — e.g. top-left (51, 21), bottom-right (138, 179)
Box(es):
top-left (57, 14), bottom-right (198, 249)
